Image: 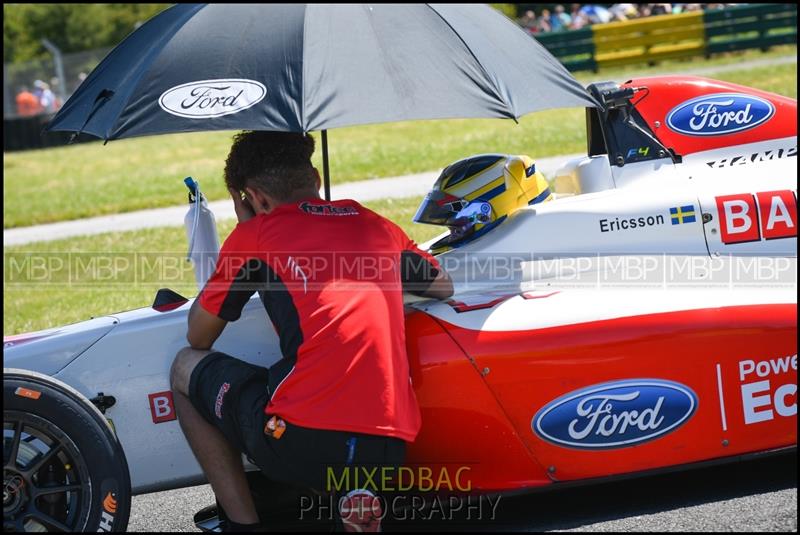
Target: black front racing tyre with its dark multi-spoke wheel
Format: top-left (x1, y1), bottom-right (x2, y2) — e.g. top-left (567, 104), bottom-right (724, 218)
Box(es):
top-left (3, 369), bottom-right (131, 531)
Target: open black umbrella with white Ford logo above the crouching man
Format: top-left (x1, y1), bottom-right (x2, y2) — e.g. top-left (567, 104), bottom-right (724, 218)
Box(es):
top-left (48, 4), bottom-right (596, 198)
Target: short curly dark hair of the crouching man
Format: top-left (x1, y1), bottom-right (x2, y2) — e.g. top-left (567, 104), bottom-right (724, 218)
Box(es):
top-left (225, 131), bottom-right (317, 201)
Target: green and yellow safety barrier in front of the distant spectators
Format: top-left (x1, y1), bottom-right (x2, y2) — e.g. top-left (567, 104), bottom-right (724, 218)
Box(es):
top-left (536, 4), bottom-right (797, 71)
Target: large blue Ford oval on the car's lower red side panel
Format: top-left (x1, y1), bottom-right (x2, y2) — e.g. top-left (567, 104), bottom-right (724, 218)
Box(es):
top-left (531, 379), bottom-right (697, 449)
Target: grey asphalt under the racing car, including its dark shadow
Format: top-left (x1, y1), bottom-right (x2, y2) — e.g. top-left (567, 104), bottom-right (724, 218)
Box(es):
top-left (128, 452), bottom-right (797, 532)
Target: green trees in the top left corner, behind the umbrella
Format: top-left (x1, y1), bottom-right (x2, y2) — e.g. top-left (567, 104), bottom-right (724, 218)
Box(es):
top-left (3, 4), bottom-right (170, 63)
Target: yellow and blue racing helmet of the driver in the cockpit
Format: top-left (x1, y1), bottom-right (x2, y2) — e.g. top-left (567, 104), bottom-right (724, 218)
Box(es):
top-left (414, 154), bottom-right (551, 254)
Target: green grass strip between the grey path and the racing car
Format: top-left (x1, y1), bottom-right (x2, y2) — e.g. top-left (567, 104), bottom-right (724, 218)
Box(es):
top-left (3, 197), bottom-right (441, 335)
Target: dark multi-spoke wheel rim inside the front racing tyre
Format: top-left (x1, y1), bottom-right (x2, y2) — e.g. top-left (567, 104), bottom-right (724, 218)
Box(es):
top-left (3, 411), bottom-right (91, 531)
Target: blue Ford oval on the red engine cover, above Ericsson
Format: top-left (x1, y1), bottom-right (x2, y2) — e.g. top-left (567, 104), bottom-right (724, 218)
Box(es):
top-left (667, 93), bottom-right (775, 136)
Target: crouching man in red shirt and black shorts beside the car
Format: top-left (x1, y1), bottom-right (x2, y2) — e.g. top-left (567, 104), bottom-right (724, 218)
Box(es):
top-left (170, 132), bottom-right (453, 531)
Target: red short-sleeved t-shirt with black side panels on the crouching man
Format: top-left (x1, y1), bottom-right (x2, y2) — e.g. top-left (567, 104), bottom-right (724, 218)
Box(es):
top-left (199, 199), bottom-right (440, 442)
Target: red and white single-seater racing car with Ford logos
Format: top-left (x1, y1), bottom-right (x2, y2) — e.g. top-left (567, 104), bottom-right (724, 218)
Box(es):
top-left (3, 77), bottom-right (797, 531)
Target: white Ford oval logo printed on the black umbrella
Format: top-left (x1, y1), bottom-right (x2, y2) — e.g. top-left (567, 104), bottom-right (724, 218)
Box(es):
top-left (158, 80), bottom-right (267, 119)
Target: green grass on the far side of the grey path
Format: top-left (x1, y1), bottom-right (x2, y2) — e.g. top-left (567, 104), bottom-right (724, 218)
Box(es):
top-left (3, 47), bottom-right (797, 228)
